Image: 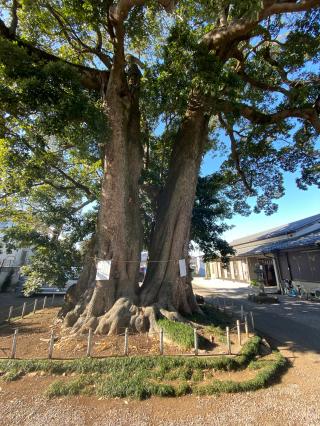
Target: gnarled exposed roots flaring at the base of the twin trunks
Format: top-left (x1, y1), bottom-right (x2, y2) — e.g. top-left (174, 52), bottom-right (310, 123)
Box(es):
top-left (62, 279), bottom-right (201, 335)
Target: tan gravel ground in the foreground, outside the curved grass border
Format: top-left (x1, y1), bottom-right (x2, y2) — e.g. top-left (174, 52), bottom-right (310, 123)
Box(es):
top-left (0, 350), bottom-right (320, 426)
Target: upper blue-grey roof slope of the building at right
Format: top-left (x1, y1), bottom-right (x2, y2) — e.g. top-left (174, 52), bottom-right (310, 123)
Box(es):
top-left (230, 214), bottom-right (320, 247)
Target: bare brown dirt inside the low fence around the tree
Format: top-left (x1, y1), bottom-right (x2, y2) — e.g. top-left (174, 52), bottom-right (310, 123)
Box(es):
top-left (0, 307), bottom-right (240, 359)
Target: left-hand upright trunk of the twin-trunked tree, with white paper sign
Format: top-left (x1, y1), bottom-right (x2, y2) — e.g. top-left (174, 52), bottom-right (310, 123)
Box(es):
top-left (65, 55), bottom-right (143, 333)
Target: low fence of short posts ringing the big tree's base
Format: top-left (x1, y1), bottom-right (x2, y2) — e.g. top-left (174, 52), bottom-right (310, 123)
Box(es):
top-left (0, 297), bottom-right (254, 359)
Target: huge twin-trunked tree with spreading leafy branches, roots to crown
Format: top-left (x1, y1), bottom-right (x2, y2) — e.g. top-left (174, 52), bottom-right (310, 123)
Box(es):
top-left (0, 0), bottom-right (320, 333)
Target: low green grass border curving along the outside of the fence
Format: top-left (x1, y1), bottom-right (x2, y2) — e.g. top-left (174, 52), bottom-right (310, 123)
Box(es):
top-left (0, 337), bottom-right (286, 399)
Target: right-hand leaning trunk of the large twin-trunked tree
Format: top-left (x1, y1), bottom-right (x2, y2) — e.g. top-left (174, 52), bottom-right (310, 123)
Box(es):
top-left (141, 106), bottom-right (208, 313)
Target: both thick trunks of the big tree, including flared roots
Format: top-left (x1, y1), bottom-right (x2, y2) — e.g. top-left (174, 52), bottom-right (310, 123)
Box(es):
top-left (64, 65), bottom-right (208, 334)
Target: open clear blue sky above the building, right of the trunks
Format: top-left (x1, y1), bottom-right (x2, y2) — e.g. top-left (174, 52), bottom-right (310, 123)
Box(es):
top-left (201, 153), bottom-right (320, 242)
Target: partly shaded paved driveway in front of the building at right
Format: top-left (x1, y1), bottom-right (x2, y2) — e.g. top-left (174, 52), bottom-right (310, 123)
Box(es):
top-left (194, 279), bottom-right (320, 354)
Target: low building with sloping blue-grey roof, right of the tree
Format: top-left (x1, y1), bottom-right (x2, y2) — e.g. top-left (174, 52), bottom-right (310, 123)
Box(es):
top-left (206, 214), bottom-right (320, 289)
